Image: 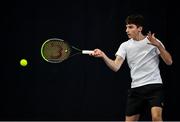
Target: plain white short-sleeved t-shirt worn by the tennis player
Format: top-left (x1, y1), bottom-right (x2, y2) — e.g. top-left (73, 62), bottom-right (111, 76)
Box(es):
top-left (115, 37), bottom-right (164, 88)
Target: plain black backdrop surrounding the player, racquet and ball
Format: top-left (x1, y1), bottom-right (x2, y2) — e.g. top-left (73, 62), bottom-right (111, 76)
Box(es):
top-left (0, 0), bottom-right (180, 121)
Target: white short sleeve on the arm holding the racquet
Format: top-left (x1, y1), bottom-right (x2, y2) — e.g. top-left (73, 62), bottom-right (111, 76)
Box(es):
top-left (115, 43), bottom-right (126, 59)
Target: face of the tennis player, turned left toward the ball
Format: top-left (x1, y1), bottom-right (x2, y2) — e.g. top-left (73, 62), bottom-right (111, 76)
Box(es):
top-left (126, 24), bottom-right (142, 39)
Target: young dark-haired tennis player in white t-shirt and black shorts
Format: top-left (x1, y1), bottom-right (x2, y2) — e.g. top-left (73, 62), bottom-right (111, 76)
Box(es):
top-left (91, 15), bottom-right (172, 121)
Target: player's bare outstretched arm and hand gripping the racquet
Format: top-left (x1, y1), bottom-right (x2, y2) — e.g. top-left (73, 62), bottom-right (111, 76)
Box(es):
top-left (91, 49), bottom-right (124, 72)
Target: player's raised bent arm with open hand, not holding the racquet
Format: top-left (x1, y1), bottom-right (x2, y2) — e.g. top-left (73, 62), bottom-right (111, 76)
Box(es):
top-left (148, 32), bottom-right (173, 65)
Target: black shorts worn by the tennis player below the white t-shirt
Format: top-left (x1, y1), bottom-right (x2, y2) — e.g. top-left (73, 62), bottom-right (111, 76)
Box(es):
top-left (126, 84), bottom-right (164, 116)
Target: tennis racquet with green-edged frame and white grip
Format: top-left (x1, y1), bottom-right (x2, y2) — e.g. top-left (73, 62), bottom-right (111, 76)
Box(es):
top-left (41, 38), bottom-right (93, 63)
